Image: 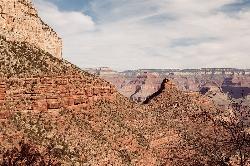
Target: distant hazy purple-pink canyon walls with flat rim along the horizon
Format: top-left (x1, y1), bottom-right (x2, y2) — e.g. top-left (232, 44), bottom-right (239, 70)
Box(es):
top-left (87, 67), bottom-right (250, 105)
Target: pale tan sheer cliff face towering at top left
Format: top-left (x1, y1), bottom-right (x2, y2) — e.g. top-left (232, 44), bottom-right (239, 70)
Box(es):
top-left (0, 0), bottom-right (62, 59)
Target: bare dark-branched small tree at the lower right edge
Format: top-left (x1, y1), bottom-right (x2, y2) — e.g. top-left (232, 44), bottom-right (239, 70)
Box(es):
top-left (218, 101), bottom-right (250, 166)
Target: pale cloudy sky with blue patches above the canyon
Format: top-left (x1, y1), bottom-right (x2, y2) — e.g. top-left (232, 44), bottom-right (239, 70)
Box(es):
top-left (33, 0), bottom-right (250, 71)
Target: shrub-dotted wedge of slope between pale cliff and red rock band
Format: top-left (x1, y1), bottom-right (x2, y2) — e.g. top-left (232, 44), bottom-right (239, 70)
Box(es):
top-left (0, 36), bottom-right (85, 77)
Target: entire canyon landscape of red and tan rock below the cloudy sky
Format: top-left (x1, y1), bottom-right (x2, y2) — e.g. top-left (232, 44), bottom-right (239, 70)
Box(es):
top-left (0, 0), bottom-right (250, 166)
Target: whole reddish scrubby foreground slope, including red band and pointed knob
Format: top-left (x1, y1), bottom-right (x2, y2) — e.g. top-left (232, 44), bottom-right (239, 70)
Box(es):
top-left (0, 38), bottom-right (248, 166)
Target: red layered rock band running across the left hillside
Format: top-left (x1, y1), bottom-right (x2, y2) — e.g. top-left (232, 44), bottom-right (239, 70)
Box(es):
top-left (0, 75), bottom-right (115, 111)
